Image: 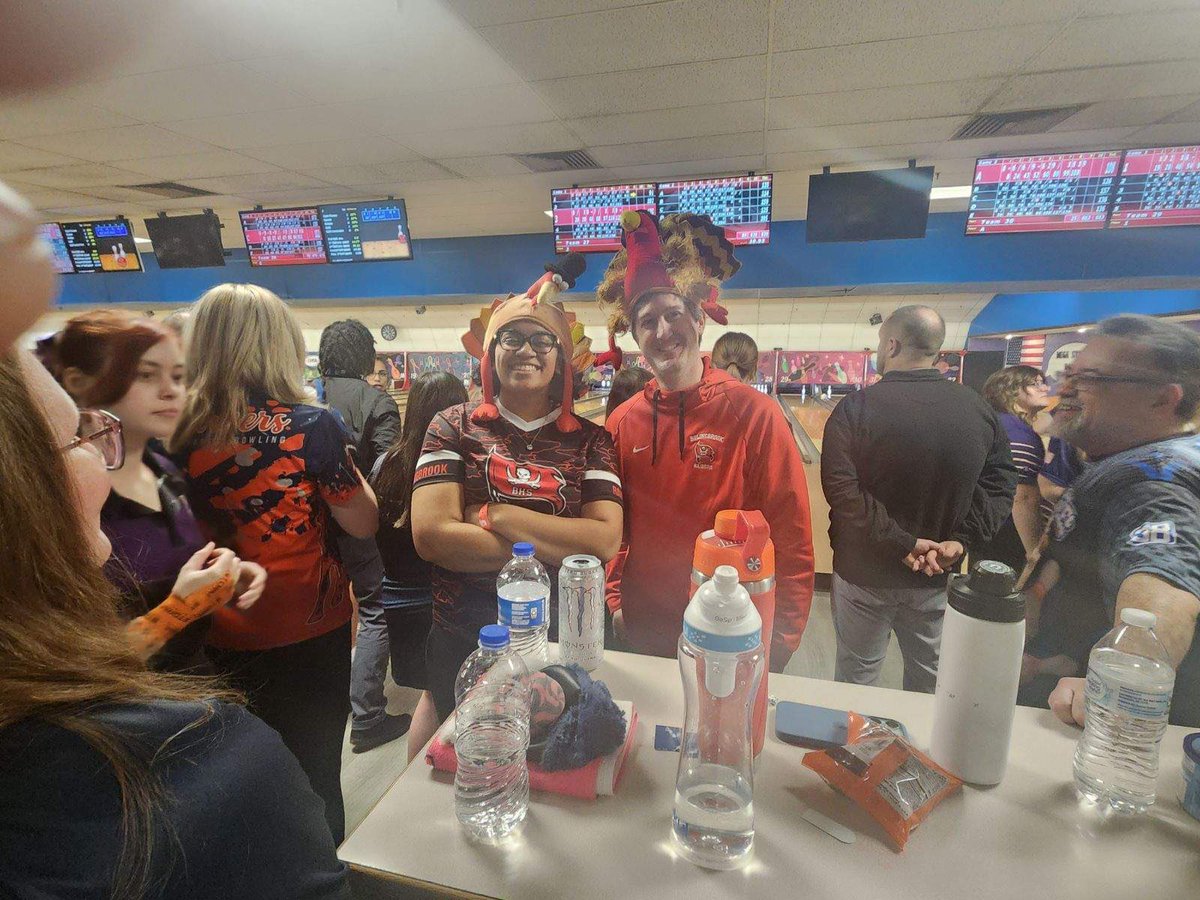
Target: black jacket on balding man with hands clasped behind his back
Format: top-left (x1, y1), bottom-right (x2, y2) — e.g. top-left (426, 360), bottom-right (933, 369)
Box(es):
top-left (821, 368), bottom-right (1016, 588)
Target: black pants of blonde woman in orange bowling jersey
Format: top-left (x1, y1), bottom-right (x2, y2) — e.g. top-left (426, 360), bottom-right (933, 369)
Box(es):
top-left (209, 623), bottom-right (350, 845)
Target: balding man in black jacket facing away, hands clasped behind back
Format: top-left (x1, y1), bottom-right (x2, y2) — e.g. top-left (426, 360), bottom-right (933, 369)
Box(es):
top-left (821, 306), bottom-right (1016, 692)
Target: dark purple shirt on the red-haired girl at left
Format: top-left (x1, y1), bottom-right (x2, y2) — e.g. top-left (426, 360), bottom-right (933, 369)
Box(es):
top-left (100, 449), bottom-right (212, 671)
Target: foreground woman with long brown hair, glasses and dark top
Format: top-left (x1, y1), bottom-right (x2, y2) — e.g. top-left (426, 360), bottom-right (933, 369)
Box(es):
top-left (0, 354), bottom-right (348, 900)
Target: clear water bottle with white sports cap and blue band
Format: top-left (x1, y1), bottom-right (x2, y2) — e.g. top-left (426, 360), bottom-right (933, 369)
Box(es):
top-left (672, 565), bottom-right (766, 869)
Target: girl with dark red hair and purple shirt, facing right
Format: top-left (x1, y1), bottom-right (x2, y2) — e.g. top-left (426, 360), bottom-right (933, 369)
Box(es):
top-left (46, 310), bottom-right (266, 673)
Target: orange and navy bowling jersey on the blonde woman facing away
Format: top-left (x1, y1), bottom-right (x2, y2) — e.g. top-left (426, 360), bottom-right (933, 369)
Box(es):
top-left (185, 400), bottom-right (361, 650)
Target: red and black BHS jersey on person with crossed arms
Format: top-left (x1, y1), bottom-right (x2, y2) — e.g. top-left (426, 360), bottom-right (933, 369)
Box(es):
top-left (413, 403), bottom-right (622, 640)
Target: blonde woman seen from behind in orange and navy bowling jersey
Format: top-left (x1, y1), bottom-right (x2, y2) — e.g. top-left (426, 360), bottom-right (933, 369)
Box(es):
top-left (170, 284), bottom-right (378, 844)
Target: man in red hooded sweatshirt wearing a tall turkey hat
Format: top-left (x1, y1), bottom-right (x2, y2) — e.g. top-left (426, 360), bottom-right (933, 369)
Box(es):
top-left (596, 211), bottom-right (812, 672)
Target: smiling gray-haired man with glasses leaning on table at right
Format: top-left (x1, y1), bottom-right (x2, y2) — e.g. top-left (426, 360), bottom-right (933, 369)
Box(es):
top-left (1021, 316), bottom-right (1200, 726)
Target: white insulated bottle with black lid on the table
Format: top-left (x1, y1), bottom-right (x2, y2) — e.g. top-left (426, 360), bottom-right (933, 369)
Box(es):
top-left (929, 559), bottom-right (1025, 785)
